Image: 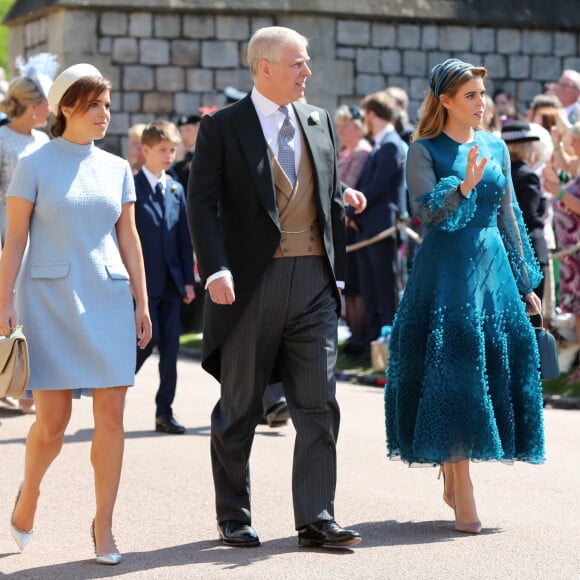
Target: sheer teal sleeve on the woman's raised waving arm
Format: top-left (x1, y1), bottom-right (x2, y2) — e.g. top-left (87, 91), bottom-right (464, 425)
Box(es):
top-left (407, 143), bottom-right (477, 232)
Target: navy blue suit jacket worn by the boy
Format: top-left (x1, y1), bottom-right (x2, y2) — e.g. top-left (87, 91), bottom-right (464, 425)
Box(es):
top-left (135, 171), bottom-right (194, 298)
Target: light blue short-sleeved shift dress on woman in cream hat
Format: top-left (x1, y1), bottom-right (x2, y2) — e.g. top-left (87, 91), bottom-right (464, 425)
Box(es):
top-left (7, 137), bottom-right (137, 397)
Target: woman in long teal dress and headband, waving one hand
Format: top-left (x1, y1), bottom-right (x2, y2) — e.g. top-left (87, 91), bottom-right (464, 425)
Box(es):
top-left (385, 59), bottom-right (544, 533)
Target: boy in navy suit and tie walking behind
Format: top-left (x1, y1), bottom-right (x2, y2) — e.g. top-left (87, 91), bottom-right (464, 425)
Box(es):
top-left (135, 121), bottom-right (195, 433)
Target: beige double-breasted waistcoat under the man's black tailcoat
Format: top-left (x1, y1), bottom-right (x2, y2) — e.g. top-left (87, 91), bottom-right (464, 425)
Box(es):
top-left (270, 131), bottom-right (324, 258)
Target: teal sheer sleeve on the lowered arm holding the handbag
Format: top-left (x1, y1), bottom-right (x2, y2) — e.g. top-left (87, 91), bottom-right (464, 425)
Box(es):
top-left (498, 142), bottom-right (542, 296)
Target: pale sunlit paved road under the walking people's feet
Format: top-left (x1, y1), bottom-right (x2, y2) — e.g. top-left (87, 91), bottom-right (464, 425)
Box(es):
top-left (0, 358), bottom-right (580, 580)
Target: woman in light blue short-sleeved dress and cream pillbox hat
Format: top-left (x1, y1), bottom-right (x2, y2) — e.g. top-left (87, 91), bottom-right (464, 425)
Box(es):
top-left (0, 64), bottom-right (151, 564)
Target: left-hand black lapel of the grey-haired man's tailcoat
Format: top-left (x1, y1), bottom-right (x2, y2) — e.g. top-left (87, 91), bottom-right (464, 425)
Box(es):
top-left (233, 94), bottom-right (279, 224)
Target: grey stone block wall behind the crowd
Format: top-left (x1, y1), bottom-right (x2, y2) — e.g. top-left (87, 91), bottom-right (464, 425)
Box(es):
top-left (5, 0), bottom-right (580, 154)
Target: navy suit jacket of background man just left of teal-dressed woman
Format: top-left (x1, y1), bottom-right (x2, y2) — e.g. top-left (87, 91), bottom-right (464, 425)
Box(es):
top-left (347, 129), bottom-right (407, 238)
